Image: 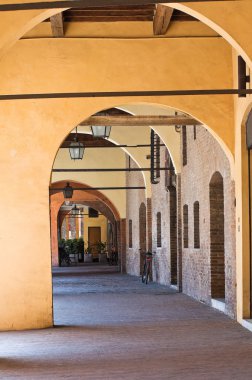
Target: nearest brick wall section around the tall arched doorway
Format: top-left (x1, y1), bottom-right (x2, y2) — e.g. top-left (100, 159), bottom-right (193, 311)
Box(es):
top-left (181, 127), bottom-right (236, 317)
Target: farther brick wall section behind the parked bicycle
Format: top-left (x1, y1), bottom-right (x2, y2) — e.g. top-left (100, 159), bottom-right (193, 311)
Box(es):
top-left (126, 147), bottom-right (178, 285)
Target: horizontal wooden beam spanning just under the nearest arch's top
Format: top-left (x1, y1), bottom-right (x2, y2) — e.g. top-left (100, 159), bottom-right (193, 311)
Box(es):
top-left (80, 115), bottom-right (202, 127)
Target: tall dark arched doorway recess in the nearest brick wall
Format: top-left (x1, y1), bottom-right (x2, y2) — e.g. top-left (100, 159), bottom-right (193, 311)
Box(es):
top-left (209, 172), bottom-right (225, 298)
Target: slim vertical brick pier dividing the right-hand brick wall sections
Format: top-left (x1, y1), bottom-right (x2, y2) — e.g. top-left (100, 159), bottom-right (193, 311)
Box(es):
top-left (177, 174), bottom-right (183, 292)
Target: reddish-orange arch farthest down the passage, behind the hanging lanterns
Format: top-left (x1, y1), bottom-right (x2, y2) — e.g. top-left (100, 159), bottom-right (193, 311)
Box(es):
top-left (50, 181), bottom-right (120, 266)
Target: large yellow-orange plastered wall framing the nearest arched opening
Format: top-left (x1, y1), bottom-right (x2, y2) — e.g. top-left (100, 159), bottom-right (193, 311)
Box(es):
top-left (0, 33), bottom-right (234, 329)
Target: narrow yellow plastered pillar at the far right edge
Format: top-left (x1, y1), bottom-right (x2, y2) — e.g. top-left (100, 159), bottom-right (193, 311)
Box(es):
top-left (233, 46), bottom-right (252, 322)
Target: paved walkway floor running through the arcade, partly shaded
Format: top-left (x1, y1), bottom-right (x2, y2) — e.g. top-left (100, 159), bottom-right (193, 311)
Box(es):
top-left (0, 266), bottom-right (252, 380)
